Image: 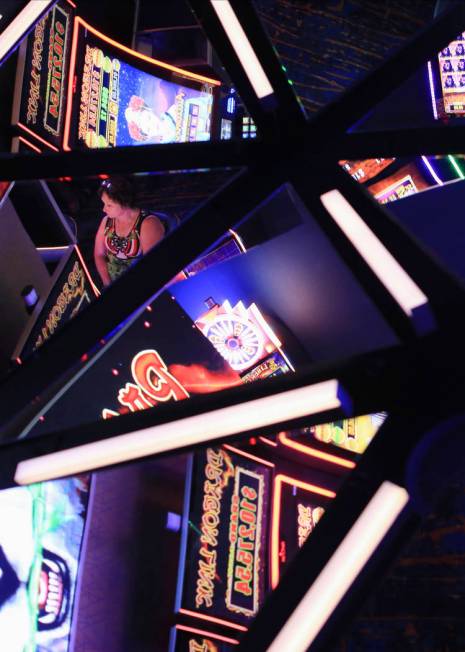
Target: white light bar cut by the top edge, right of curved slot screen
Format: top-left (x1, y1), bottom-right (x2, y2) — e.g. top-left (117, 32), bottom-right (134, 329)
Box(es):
top-left (210, 0), bottom-right (274, 99)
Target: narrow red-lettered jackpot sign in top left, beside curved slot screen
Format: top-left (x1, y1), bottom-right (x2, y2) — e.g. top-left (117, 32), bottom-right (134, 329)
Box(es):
top-left (13, 0), bottom-right (73, 148)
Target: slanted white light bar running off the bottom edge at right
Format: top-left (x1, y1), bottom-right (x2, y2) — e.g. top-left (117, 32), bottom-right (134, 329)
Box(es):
top-left (267, 482), bottom-right (409, 652)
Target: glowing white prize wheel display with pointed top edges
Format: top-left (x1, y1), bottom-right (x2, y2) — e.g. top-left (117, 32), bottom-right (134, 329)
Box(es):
top-left (195, 301), bottom-right (290, 377)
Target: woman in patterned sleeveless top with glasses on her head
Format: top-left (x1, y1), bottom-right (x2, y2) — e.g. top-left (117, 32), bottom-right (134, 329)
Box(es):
top-left (94, 177), bottom-right (165, 285)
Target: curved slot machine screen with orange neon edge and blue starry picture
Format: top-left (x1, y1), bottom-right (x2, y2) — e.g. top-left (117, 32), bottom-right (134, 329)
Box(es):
top-left (64, 18), bottom-right (220, 149)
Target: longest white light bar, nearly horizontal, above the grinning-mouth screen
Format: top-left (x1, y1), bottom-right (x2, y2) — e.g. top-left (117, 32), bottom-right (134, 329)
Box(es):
top-left (15, 380), bottom-right (343, 485)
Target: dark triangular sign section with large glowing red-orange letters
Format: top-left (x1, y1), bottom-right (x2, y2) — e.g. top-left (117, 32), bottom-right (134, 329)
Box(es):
top-left (28, 294), bottom-right (241, 433)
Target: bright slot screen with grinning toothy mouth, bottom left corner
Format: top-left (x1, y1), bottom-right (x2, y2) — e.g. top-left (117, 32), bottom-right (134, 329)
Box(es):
top-left (0, 475), bottom-right (91, 652)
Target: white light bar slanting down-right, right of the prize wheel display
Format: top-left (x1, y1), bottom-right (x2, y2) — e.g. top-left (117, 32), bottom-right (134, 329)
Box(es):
top-left (320, 190), bottom-right (428, 317)
